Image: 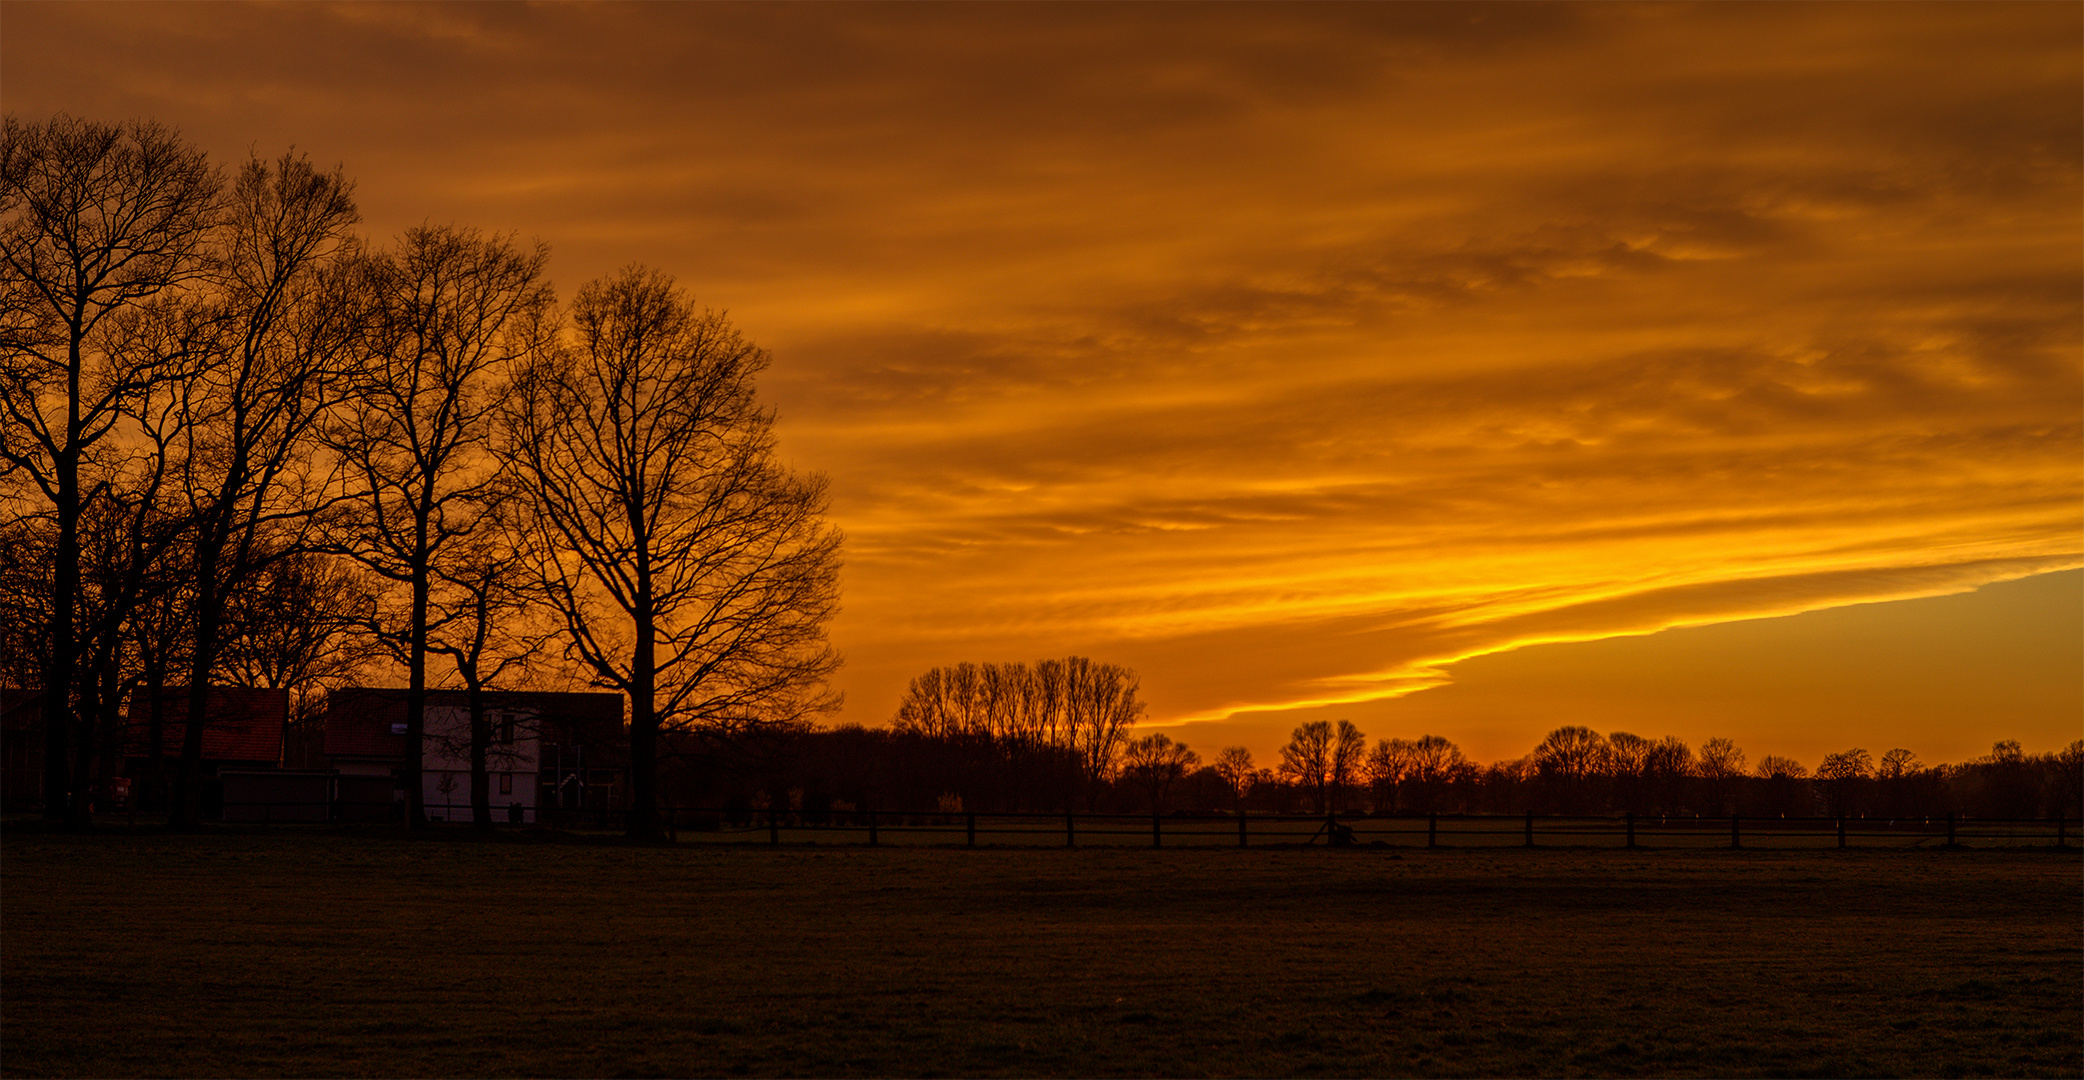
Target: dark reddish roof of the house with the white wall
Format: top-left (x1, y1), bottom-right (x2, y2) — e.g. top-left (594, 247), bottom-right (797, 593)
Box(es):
top-left (325, 686), bottom-right (629, 761)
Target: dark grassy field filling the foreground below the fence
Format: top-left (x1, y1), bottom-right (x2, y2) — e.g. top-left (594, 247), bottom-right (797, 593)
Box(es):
top-left (0, 828), bottom-right (2084, 1076)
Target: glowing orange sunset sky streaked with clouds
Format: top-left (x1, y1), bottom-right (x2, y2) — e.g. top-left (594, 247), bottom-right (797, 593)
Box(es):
top-left (0, 0), bottom-right (2084, 767)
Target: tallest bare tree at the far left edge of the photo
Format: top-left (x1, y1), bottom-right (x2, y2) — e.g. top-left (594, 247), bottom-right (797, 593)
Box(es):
top-left (0, 115), bottom-right (223, 819)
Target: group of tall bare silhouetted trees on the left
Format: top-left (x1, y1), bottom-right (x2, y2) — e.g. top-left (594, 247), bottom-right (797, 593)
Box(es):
top-left (0, 115), bottom-right (840, 836)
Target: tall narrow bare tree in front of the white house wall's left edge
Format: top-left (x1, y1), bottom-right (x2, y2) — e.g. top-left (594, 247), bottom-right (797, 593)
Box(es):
top-left (327, 225), bottom-right (550, 828)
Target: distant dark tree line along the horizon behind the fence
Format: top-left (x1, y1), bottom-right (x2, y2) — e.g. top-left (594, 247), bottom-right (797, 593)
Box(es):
top-left (704, 683), bottom-right (2084, 817)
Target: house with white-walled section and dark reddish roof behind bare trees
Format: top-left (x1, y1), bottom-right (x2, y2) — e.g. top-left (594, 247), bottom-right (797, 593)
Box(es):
top-left (325, 686), bottom-right (629, 821)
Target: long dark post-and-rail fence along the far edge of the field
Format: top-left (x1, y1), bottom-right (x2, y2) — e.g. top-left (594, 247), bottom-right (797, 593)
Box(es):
top-left (211, 801), bottom-right (2078, 849)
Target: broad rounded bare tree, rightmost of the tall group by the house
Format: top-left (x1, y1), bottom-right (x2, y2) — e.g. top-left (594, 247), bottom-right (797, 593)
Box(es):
top-left (504, 267), bottom-right (840, 838)
